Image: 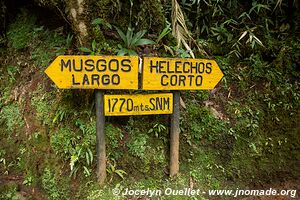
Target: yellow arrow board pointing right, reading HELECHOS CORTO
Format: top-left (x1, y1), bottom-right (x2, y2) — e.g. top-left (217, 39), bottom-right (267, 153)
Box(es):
top-left (142, 57), bottom-right (223, 90)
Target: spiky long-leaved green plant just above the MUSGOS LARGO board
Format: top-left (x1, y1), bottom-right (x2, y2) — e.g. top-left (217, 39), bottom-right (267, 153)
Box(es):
top-left (115, 27), bottom-right (155, 56)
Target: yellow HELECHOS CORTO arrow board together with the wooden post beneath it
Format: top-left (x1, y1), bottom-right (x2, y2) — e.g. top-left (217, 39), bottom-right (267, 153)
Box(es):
top-left (142, 57), bottom-right (223, 176)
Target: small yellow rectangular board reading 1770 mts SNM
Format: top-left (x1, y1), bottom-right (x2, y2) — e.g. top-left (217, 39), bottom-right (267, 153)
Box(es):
top-left (104, 93), bottom-right (173, 116)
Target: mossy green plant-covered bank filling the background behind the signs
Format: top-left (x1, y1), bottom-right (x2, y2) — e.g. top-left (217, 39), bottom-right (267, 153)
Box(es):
top-left (0, 0), bottom-right (300, 199)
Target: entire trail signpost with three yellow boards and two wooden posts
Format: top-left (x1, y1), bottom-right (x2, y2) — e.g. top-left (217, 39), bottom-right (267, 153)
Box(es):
top-left (45, 56), bottom-right (223, 184)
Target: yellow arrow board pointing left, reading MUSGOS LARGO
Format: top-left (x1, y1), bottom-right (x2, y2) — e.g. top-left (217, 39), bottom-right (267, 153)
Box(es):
top-left (45, 56), bottom-right (139, 89)
